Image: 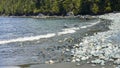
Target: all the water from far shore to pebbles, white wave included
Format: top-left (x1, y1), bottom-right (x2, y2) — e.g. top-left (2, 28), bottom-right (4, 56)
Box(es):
top-left (0, 17), bottom-right (108, 68)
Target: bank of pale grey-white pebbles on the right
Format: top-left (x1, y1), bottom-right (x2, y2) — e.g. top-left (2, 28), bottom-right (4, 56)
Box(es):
top-left (71, 13), bottom-right (120, 68)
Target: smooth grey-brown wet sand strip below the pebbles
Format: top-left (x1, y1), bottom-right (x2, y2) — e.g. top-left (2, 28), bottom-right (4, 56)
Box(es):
top-left (30, 63), bottom-right (115, 68)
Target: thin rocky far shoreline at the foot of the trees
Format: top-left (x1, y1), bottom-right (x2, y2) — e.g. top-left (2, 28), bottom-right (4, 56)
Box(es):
top-left (0, 12), bottom-right (119, 20)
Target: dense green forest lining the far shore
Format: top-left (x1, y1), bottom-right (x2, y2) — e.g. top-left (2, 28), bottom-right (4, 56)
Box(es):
top-left (0, 0), bottom-right (120, 15)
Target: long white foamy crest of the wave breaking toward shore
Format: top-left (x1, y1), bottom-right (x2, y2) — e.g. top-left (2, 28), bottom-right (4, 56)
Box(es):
top-left (0, 21), bottom-right (100, 44)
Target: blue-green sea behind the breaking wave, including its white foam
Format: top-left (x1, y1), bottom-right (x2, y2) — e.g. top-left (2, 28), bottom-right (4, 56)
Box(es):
top-left (0, 17), bottom-right (96, 44)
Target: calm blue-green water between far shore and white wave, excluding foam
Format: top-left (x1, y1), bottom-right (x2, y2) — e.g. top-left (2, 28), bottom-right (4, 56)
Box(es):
top-left (0, 18), bottom-right (94, 40)
